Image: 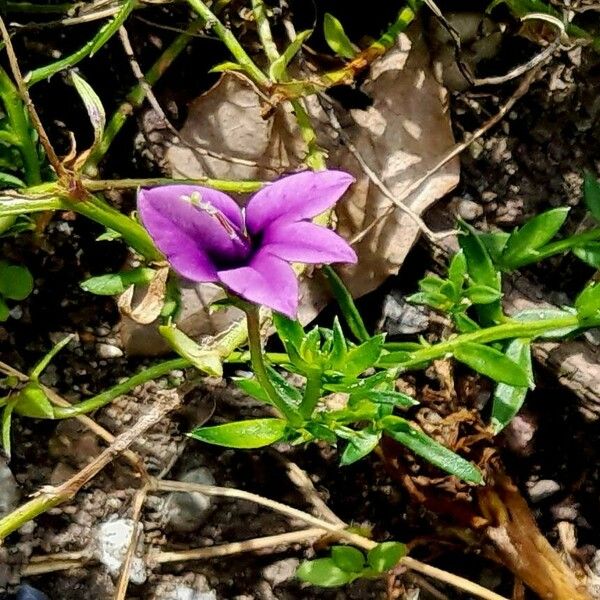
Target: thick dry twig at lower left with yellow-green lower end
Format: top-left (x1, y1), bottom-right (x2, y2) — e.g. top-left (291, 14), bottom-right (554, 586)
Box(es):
top-left (0, 395), bottom-right (180, 541)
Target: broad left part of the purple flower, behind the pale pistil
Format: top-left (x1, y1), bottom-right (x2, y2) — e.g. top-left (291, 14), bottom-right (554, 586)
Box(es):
top-left (138, 185), bottom-right (247, 281)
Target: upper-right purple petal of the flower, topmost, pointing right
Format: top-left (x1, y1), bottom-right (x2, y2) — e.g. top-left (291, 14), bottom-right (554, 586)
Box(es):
top-left (246, 171), bottom-right (354, 234)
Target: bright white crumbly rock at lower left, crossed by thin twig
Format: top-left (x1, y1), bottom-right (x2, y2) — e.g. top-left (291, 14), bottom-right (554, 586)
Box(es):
top-left (94, 519), bottom-right (146, 585)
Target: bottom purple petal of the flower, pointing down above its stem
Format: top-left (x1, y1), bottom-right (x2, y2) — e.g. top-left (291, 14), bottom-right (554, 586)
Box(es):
top-left (218, 250), bottom-right (298, 319)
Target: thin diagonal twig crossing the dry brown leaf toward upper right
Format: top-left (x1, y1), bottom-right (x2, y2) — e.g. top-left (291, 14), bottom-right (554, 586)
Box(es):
top-left (351, 68), bottom-right (544, 244)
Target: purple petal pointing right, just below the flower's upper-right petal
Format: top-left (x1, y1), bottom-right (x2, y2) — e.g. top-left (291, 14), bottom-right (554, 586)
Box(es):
top-left (261, 221), bottom-right (358, 264)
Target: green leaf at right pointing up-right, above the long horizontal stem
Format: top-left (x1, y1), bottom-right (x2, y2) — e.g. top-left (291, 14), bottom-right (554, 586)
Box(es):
top-left (501, 207), bottom-right (569, 269)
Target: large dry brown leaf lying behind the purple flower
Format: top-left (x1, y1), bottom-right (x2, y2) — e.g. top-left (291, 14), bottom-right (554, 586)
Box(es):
top-left (122, 29), bottom-right (458, 353)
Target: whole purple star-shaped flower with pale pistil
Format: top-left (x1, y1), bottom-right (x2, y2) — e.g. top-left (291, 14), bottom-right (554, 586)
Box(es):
top-left (138, 171), bottom-right (357, 317)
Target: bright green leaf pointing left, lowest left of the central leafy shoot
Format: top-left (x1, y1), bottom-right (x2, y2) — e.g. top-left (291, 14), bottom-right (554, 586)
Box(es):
top-left (188, 419), bottom-right (287, 449)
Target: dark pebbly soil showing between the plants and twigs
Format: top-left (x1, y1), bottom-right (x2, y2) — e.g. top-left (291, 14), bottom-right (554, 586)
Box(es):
top-left (0, 3), bottom-right (600, 600)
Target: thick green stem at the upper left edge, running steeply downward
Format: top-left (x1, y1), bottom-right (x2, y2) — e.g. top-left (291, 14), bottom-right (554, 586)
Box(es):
top-left (0, 67), bottom-right (42, 185)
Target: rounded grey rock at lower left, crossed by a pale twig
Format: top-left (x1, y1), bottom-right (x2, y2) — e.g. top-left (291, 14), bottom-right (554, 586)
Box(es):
top-left (165, 467), bottom-right (215, 533)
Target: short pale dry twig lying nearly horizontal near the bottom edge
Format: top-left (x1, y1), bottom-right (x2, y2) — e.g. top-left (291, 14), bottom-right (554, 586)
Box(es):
top-left (148, 527), bottom-right (327, 564)
